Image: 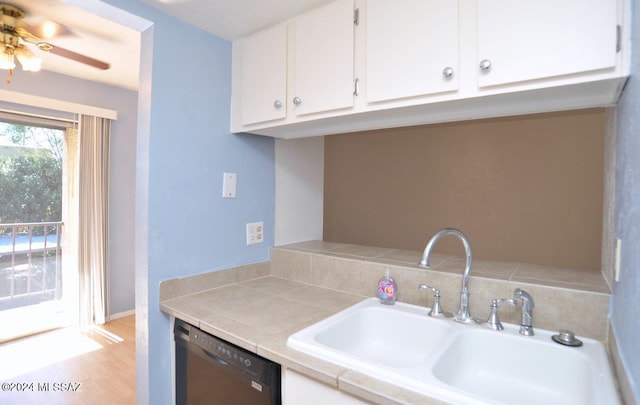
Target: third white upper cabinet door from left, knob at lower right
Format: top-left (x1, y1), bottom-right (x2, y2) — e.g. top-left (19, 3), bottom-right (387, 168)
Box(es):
top-left (364, 0), bottom-right (458, 102)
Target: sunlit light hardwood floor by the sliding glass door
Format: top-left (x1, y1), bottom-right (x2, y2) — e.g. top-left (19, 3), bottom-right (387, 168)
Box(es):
top-left (0, 316), bottom-right (136, 405)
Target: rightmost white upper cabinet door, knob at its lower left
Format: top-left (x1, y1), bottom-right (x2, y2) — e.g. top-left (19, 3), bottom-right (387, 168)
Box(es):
top-left (477, 0), bottom-right (617, 87)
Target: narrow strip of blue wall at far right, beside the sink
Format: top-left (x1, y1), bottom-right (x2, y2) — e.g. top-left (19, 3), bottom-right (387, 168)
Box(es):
top-left (611, 0), bottom-right (640, 403)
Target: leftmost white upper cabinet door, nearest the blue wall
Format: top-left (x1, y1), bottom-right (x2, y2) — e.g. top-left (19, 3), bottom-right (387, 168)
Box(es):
top-left (241, 25), bottom-right (287, 125)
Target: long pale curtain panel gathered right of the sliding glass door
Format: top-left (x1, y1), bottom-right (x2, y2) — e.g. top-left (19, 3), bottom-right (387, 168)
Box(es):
top-left (78, 115), bottom-right (111, 327)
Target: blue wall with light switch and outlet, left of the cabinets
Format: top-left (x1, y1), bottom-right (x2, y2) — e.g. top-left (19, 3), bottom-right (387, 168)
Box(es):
top-left (88, 0), bottom-right (275, 405)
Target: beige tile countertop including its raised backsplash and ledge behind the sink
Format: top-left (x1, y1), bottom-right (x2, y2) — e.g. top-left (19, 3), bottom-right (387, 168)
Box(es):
top-left (160, 241), bottom-right (609, 404)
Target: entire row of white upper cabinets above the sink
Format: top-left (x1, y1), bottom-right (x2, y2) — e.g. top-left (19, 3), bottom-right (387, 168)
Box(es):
top-left (231, 0), bottom-right (631, 138)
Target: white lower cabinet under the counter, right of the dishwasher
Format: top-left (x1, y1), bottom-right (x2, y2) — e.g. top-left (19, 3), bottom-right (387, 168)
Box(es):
top-left (282, 368), bottom-right (369, 405)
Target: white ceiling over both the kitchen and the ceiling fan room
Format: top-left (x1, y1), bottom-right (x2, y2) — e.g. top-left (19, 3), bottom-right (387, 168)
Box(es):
top-left (5, 0), bottom-right (331, 90)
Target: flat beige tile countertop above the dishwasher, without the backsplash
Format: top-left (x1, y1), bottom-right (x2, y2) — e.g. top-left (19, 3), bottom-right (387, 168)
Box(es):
top-left (160, 276), bottom-right (448, 404)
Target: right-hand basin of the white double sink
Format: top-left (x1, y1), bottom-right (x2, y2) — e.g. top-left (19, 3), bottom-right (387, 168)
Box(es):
top-left (432, 330), bottom-right (613, 405)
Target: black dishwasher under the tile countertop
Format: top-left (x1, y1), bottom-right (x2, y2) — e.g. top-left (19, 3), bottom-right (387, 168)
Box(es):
top-left (173, 319), bottom-right (282, 405)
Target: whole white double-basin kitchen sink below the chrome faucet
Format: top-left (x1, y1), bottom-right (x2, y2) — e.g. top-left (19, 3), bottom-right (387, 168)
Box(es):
top-left (287, 298), bottom-right (619, 405)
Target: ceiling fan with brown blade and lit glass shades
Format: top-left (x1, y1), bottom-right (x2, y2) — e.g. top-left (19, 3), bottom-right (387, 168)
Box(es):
top-left (0, 3), bottom-right (109, 83)
